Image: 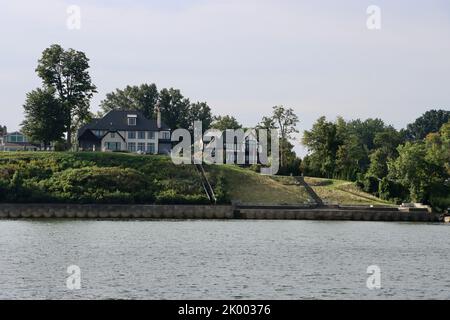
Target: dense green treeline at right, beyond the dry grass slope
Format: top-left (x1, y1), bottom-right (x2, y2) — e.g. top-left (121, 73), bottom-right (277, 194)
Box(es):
top-left (301, 110), bottom-right (450, 209)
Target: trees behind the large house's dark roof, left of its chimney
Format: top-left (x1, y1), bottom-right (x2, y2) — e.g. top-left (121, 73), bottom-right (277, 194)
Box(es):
top-left (100, 83), bottom-right (159, 119)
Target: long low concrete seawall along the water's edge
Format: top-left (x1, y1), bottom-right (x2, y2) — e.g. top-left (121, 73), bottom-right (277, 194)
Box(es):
top-left (0, 204), bottom-right (440, 222)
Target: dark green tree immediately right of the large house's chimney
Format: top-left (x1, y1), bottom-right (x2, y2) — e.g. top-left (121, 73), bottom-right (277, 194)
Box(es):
top-left (159, 88), bottom-right (191, 129)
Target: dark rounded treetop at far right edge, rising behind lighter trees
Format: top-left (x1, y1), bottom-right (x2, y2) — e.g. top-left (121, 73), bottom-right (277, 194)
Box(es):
top-left (406, 110), bottom-right (450, 141)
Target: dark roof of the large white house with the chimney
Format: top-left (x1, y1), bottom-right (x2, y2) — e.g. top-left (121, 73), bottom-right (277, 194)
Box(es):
top-left (78, 110), bottom-right (170, 136)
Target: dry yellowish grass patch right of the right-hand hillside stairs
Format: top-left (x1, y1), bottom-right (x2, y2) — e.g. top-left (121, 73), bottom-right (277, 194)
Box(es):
top-left (305, 177), bottom-right (393, 205)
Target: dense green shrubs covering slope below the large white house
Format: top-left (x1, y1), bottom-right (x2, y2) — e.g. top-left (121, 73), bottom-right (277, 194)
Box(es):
top-left (0, 152), bottom-right (216, 204)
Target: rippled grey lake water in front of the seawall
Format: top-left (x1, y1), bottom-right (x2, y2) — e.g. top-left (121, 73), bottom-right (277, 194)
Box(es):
top-left (0, 220), bottom-right (450, 299)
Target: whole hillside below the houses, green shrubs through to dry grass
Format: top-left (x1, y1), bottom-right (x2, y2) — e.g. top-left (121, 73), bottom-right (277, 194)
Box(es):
top-left (0, 152), bottom-right (392, 204)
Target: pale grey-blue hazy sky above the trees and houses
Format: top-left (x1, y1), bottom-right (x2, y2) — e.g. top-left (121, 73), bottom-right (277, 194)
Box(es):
top-left (0, 0), bottom-right (450, 154)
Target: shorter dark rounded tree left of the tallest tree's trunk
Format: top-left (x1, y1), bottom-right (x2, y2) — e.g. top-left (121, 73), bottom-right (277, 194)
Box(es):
top-left (22, 88), bottom-right (65, 147)
